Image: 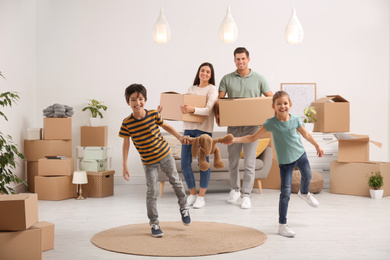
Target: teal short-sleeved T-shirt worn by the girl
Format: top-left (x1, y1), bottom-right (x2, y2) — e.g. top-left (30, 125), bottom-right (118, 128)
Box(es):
top-left (263, 114), bottom-right (305, 164)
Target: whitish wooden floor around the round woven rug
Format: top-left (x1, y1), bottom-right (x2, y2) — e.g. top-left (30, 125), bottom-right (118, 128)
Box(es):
top-left (38, 183), bottom-right (390, 260)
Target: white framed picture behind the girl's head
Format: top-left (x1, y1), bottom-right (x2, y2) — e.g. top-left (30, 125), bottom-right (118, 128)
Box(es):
top-left (280, 83), bottom-right (317, 118)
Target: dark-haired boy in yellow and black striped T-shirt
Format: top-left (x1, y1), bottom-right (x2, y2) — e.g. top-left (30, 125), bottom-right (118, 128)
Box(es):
top-left (119, 84), bottom-right (191, 237)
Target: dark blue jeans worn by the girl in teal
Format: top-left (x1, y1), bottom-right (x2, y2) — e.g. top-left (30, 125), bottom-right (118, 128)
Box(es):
top-left (279, 153), bottom-right (312, 224)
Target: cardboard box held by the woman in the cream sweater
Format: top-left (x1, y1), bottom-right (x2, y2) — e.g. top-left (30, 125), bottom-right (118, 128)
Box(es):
top-left (160, 92), bottom-right (207, 122)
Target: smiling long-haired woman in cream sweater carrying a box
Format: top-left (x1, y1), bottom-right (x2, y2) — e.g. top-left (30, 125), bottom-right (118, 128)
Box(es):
top-left (180, 62), bottom-right (218, 209)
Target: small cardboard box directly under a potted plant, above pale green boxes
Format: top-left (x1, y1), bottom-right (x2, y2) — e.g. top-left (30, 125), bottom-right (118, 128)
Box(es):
top-left (80, 126), bottom-right (108, 146)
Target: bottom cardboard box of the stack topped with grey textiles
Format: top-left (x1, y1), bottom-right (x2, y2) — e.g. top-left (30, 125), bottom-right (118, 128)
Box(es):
top-left (35, 176), bottom-right (76, 201)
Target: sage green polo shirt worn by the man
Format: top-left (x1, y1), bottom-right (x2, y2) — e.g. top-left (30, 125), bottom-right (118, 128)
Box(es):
top-left (219, 70), bottom-right (271, 98)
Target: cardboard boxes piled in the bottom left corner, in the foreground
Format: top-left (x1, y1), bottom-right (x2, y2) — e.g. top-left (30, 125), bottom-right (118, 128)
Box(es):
top-left (0, 193), bottom-right (54, 260)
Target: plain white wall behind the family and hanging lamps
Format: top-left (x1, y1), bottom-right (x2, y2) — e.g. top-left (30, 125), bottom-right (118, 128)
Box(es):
top-left (0, 0), bottom-right (390, 187)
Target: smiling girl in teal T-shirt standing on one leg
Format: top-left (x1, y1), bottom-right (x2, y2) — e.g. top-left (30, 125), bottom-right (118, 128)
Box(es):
top-left (228, 91), bottom-right (324, 237)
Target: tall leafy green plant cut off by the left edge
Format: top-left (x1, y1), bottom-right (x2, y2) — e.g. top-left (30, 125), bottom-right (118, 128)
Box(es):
top-left (0, 72), bottom-right (27, 194)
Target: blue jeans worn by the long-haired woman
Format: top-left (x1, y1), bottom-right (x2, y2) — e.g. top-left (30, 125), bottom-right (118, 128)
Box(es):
top-left (181, 130), bottom-right (211, 189)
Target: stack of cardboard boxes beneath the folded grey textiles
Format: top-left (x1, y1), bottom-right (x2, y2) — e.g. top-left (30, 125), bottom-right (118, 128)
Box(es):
top-left (24, 118), bottom-right (76, 200)
